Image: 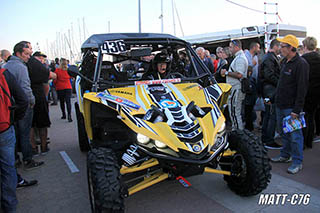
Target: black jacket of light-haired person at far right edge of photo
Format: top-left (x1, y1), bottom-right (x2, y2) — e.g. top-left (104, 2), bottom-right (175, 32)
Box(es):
top-left (302, 52), bottom-right (320, 98)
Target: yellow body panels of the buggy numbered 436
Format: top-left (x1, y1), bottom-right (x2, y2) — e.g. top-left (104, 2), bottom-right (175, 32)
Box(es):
top-left (83, 83), bottom-right (231, 152)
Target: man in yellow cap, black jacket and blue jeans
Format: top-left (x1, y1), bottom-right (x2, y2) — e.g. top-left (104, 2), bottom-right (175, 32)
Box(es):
top-left (271, 34), bottom-right (309, 174)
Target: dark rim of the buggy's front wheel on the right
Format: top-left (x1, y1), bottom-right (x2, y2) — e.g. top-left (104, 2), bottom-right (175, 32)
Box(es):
top-left (231, 154), bottom-right (247, 185)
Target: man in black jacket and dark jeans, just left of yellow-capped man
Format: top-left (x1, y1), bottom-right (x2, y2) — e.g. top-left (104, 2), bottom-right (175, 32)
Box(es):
top-left (258, 39), bottom-right (281, 149)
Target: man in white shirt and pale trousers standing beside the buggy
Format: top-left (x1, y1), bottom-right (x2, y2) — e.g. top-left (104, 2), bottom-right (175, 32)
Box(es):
top-left (221, 40), bottom-right (248, 130)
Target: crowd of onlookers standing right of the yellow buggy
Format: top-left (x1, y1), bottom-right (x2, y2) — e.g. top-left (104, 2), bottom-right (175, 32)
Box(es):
top-left (197, 35), bottom-right (320, 174)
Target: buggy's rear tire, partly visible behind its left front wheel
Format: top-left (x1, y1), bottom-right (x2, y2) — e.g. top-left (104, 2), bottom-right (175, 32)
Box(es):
top-left (74, 102), bottom-right (90, 152)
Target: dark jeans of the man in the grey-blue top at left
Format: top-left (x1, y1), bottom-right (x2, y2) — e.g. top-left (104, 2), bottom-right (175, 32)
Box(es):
top-left (16, 107), bottom-right (33, 161)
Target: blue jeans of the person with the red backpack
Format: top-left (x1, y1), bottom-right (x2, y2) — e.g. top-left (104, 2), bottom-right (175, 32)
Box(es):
top-left (0, 126), bottom-right (18, 212)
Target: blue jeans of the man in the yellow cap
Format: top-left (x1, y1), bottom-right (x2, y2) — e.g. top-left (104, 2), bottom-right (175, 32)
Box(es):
top-left (276, 107), bottom-right (303, 165)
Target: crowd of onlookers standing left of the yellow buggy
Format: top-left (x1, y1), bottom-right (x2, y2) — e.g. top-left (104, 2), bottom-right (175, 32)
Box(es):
top-left (0, 41), bottom-right (72, 212)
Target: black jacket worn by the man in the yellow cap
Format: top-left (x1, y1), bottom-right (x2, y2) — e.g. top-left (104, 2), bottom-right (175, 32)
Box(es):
top-left (275, 54), bottom-right (309, 114)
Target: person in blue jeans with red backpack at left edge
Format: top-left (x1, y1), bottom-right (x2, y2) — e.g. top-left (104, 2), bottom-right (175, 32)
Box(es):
top-left (0, 69), bottom-right (29, 212)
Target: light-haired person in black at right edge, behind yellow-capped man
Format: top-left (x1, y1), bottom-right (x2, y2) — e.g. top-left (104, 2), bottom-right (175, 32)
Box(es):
top-left (302, 37), bottom-right (320, 148)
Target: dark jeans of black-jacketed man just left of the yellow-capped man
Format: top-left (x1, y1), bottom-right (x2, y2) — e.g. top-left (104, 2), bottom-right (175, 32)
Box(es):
top-left (261, 104), bottom-right (276, 144)
